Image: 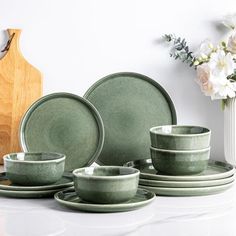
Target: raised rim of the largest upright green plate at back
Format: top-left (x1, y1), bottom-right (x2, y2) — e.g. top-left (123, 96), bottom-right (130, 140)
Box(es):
top-left (83, 71), bottom-right (177, 165)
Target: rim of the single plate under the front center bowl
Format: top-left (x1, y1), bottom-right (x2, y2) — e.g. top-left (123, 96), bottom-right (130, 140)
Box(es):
top-left (54, 188), bottom-right (156, 212)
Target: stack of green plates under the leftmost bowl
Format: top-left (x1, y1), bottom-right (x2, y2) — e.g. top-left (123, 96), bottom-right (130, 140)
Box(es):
top-left (0, 172), bottom-right (73, 198)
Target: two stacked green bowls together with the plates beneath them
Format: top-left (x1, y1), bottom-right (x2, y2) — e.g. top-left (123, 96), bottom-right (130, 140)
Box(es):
top-left (123, 125), bottom-right (235, 196)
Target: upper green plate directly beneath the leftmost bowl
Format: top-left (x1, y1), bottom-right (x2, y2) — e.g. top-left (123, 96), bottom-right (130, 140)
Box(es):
top-left (0, 172), bottom-right (74, 191)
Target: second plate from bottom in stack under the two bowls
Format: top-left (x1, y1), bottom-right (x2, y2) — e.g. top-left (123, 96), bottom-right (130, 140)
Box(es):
top-left (139, 175), bottom-right (235, 188)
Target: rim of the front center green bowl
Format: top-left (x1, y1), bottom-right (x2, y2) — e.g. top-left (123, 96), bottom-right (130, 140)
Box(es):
top-left (72, 166), bottom-right (140, 180)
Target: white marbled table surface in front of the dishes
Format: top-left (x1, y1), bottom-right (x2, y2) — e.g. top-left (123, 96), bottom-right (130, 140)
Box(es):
top-left (0, 166), bottom-right (236, 236)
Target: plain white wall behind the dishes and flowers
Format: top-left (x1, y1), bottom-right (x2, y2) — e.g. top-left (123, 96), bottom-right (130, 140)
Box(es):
top-left (0, 0), bottom-right (236, 160)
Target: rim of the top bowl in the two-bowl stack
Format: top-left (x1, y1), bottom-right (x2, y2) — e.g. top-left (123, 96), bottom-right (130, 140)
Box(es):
top-left (149, 125), bottom-right (211, 137)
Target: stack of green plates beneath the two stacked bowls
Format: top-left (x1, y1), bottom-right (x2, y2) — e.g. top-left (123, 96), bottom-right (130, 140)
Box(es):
top-left (125, 159), bottom-right (235, 196)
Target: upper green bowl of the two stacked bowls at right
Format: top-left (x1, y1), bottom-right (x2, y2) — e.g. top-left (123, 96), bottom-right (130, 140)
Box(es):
top-left (150, 125), bottom-right (211, 150)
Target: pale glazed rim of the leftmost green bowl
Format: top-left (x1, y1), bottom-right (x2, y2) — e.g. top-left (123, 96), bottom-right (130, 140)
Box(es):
top-left (3, 152), bottom-right (66, 164)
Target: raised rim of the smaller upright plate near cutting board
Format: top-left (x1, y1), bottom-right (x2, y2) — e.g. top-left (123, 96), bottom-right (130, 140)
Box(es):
top-left (18, 92), bottom-right (105, 171)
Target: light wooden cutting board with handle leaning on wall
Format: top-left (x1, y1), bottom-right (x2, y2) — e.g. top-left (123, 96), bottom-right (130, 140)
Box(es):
top-left (0, 29), bottom-right (42, 164)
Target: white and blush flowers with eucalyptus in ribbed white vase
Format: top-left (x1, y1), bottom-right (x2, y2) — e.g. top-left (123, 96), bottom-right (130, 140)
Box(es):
top-left (164, 14), bottom-right (236, 166)
